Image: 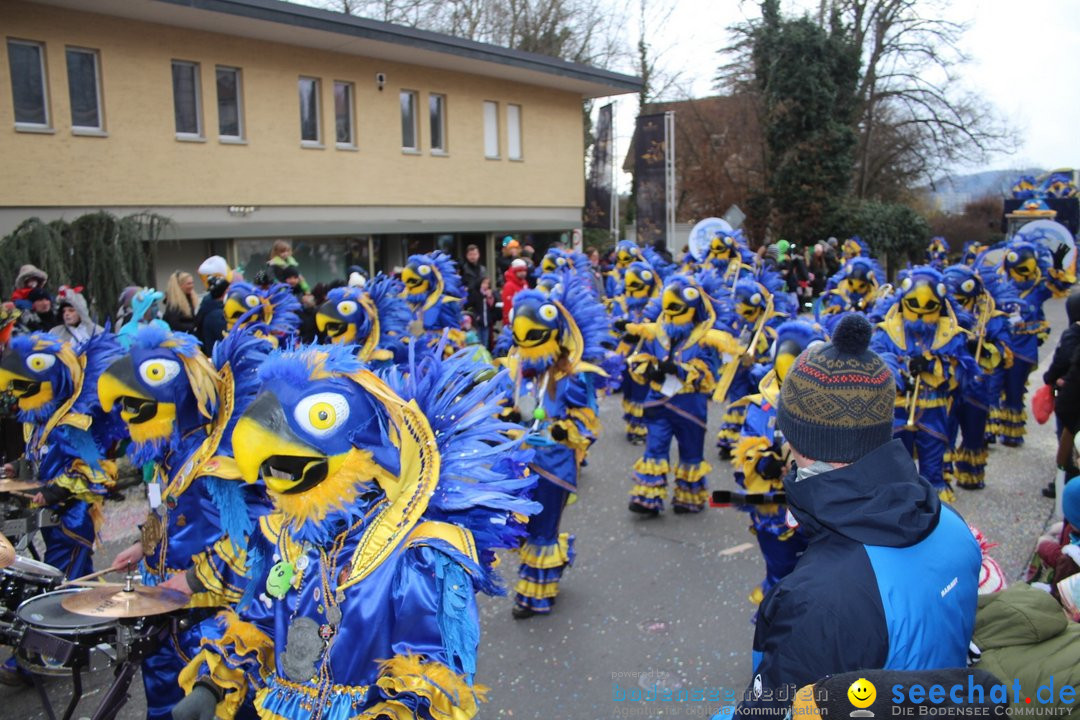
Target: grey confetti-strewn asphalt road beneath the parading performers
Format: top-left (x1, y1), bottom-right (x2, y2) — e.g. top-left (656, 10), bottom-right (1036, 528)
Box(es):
top-left (0, 301), bottom-right (1065, 720)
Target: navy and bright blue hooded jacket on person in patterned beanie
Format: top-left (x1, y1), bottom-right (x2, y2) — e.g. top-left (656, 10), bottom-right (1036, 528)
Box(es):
top-left (740, 440), bottom-right (982, 715)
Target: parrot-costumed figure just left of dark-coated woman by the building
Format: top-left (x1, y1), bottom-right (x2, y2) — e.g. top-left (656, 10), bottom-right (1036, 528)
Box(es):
top-left (402, 250), bottom-right (467, 353)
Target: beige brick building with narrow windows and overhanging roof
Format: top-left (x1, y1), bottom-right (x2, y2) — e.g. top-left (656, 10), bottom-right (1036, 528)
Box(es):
top-left (0, 0), bottom-right (639, 286)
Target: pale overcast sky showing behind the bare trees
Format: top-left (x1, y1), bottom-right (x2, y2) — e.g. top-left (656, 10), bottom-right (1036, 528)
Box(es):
top-left (600, 0), bottom-right (1080, 182)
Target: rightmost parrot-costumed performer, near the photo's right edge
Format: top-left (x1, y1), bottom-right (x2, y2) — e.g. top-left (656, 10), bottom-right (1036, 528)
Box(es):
top-left (978, 237), bottom-right (1076, 447)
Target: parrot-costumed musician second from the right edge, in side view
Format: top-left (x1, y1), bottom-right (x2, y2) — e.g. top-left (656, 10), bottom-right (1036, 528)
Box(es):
top-left (943, 264), bottom-right (1017, 490)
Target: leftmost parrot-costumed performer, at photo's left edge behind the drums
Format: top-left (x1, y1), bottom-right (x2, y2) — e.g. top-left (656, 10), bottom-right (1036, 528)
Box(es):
top-left (0, 332), bottom-right (126, 579)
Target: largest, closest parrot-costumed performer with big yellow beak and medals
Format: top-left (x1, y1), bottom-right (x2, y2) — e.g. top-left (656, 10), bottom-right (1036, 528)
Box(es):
top-left (176, 345), bottom-right (537, 720)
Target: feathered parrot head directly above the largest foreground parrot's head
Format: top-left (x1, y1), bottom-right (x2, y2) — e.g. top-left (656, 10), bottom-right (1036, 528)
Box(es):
top-left (315, 273), bottom-right (413, 363)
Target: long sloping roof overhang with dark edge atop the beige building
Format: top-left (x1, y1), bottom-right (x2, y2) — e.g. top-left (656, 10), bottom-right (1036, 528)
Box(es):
top-left (23, 0), bottom-right (642, 97)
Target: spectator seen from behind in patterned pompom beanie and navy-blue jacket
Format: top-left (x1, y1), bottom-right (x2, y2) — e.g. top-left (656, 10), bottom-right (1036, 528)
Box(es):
top-left (739, 314), bottom-right (982, 717)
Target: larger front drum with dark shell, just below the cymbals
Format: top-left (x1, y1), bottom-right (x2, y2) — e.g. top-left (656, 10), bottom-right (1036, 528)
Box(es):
top-left (15, 588), bottom-right (117, 676)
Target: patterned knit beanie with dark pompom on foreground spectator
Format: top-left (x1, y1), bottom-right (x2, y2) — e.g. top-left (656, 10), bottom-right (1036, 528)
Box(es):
top-left (777, 313), bottom-right (896, 463)
